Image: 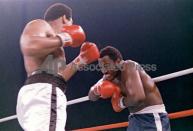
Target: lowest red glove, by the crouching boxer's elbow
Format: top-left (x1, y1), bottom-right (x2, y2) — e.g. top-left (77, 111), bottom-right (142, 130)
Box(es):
top-left (111, 88), bottom-right (126, 112)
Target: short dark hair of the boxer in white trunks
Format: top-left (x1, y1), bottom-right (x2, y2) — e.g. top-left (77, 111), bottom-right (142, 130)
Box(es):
top-left (44, 3), bottom-right (72, 21)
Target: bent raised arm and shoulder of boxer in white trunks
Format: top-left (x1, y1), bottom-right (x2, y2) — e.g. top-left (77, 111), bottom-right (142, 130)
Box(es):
top-left (20, 20), bottom-right (61, 56)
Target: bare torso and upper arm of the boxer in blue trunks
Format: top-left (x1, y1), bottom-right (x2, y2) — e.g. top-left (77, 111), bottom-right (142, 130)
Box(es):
top-left (112, 60), bottom-right (163, 113)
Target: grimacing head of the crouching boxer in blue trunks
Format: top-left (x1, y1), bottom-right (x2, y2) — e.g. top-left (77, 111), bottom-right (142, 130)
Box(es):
top-left (98, 46), bottom-right (123, 80)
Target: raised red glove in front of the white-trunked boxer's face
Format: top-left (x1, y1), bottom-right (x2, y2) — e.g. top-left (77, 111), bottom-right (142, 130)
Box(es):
top-left (62, 25), bottom-right (86, 47)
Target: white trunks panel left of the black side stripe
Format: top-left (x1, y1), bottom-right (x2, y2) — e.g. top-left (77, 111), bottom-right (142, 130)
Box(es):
top-left (17, 83), bottom-right (52, 131)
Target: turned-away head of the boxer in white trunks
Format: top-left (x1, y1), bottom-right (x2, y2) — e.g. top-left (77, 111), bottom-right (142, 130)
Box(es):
top-left (44, 3), bottom-right (72, 31)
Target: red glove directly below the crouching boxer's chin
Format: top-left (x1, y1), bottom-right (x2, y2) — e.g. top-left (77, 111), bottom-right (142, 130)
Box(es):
top-left (91, 79), bottom-right (118, 99)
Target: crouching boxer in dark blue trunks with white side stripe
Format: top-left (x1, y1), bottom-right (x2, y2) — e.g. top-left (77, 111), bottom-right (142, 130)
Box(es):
top-left (89, 46), bottom-right (170, 131)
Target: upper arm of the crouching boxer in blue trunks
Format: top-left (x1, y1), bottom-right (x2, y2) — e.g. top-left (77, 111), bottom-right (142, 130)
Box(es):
top-left (124, 61), bottom-right (145, 107)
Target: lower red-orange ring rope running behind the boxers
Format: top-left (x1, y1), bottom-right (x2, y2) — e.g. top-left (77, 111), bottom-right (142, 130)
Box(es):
top-left (72, 109), bottom-right (193, 131)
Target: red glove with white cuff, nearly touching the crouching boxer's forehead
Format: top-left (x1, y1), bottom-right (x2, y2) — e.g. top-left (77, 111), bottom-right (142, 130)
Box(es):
top-left (73, 42), bottom-right (100, 67)
